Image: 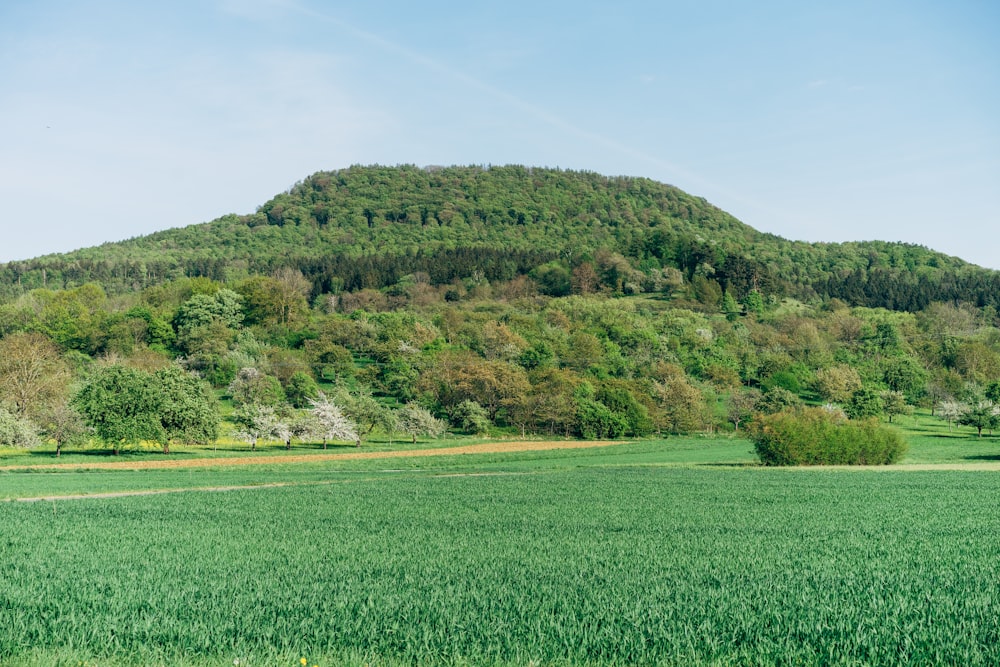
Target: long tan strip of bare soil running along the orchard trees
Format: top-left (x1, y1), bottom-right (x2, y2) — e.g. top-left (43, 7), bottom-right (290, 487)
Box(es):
top-left (0, 440), bottom-right (625, 471)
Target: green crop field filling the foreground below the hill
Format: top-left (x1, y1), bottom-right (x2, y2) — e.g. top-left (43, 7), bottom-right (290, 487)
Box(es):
top-left (0, 436), bottom-right (1000, 666)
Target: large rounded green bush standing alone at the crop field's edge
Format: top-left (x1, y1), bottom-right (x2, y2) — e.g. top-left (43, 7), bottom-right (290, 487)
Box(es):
top-left (750, 408), bottom-right (906, 465)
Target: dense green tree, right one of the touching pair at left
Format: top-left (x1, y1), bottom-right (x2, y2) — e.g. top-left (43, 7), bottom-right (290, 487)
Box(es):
top-left (153, 365), bottom-right (219, 454)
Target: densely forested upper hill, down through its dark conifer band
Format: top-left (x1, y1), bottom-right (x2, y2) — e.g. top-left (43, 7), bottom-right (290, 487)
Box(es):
top-left (0, 166), bottom-right (1000, 310)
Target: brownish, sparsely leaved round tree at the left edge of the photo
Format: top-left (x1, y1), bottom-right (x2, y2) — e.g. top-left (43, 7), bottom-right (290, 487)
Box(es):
top-left (0, 333), bottom-right (70, 417)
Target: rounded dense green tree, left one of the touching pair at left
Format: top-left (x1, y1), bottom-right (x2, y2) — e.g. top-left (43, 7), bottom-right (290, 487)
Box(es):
top-left (72, 365), bottom-right (166, 455)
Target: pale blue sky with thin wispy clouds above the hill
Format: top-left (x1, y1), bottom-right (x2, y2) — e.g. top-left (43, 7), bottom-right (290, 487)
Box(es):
top-left (0, 0), bottom-right (1000, 269)
